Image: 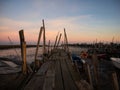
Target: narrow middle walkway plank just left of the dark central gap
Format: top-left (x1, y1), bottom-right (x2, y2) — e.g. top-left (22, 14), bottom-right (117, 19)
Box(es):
top-left (55, 60), bottom-right (64, 90)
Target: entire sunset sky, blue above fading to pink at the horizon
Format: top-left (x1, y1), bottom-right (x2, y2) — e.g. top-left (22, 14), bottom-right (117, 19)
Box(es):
top-left (0, 0), bottom-right (120, 44)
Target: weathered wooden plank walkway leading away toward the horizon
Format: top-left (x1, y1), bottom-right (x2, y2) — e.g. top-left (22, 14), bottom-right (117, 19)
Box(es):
top-left (24, 50), bottom-right (89, 90)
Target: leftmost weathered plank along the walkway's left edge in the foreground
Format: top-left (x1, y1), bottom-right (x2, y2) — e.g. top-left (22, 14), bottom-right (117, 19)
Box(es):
top-left (24, 62), bottom-right (51, 90)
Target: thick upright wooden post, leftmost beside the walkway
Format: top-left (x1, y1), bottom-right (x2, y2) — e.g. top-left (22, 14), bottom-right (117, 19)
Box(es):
top-left (19, 30), bottom-right (27, 74)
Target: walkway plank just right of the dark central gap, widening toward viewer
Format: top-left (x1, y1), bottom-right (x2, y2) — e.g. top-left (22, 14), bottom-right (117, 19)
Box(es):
top-left (60, 59), bottom-right (78, 90)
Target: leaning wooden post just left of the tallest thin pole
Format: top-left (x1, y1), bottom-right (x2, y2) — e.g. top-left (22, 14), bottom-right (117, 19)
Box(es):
top-left (35, 27), bottom-right (43, 68)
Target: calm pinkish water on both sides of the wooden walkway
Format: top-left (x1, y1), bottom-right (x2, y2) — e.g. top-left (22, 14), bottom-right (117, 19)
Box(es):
top-left (0, 47), bottom-right (87, 64)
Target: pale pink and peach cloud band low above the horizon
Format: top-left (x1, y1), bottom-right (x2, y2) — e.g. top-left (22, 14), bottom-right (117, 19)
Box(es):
top-left (0, 15), bottom-right (120, 44)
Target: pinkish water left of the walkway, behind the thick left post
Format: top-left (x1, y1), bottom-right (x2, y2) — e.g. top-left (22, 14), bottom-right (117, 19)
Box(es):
top-left (0, 47), bottom-right (42, 64)
